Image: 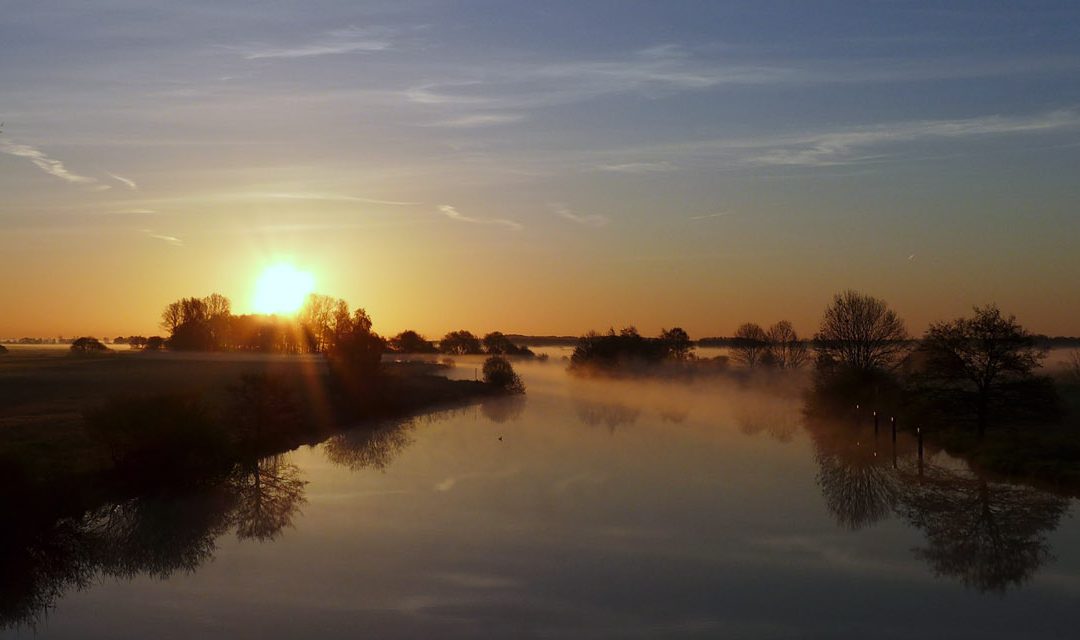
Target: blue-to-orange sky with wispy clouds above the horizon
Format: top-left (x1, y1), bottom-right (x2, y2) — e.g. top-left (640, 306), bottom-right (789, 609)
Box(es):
top-left (0, 0), bottom-right (1080, 338)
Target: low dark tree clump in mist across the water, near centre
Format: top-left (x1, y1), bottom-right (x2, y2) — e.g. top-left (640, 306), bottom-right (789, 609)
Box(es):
top-left (570, 327), bottom-right (693, 370)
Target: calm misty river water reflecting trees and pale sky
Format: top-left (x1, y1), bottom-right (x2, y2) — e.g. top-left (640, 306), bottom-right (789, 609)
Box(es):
top-left (0, 358), bottom-right (1080, 638)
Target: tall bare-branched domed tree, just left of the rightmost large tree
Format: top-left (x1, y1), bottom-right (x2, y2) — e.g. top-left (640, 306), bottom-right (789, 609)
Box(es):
top-left (814, 290), bottom-right (908, 373)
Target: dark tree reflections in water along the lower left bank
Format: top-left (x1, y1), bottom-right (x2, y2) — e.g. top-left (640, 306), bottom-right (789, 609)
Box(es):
top-left (0, 455), bottom-right (307, 629)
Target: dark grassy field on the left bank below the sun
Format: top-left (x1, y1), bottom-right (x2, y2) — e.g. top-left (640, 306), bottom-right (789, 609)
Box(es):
top-left (0, 346), bottom-right (492, 485)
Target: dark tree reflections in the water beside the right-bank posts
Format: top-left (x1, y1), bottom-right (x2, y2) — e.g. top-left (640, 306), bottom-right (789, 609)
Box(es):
top-left (806, 401), bottom-right (1069, 593)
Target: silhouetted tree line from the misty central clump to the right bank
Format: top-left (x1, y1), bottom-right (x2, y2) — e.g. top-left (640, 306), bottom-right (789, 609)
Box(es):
top-left (570, 290), bottom-right (1058, 434)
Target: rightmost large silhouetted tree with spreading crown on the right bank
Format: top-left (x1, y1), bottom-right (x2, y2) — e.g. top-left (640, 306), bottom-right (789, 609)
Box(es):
top-left (917, 304), bottom-right (1047, 435)
